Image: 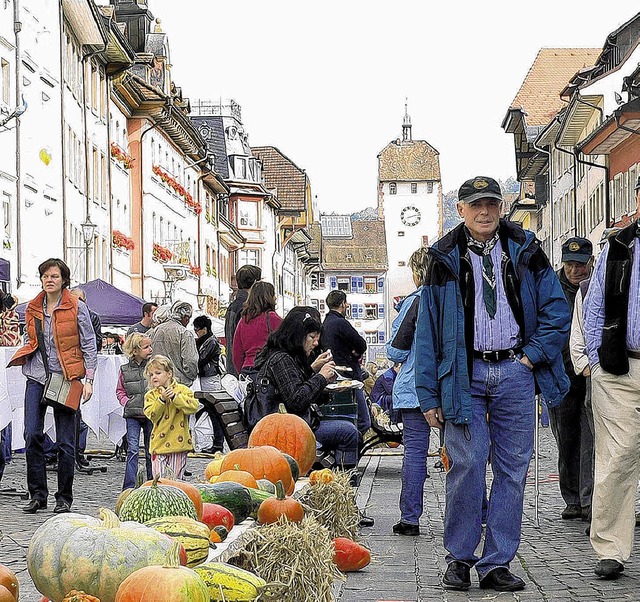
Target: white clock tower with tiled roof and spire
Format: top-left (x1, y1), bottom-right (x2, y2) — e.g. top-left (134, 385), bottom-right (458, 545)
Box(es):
top-left (378, 104), bottom-right (442, 333)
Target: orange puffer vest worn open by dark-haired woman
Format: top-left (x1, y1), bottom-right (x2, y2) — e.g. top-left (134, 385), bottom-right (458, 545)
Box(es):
top-left (9, 288), bottom-right (85, 380)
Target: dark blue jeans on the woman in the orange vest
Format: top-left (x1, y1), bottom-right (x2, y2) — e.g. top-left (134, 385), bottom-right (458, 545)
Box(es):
top-left (24, 378), bottom-right (76, 506)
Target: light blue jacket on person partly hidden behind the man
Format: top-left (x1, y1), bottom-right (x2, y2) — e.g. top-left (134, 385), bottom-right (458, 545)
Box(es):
top-left (387, 286), bottom-right (424, 410)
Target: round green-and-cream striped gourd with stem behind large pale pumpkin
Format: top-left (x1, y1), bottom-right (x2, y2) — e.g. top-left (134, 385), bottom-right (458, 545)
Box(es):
top-left (120, 477), bottom-right (197, 523)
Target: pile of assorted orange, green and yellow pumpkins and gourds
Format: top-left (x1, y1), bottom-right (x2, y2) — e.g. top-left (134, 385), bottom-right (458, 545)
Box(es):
top-left (17, 406), bottom-right (370, 602)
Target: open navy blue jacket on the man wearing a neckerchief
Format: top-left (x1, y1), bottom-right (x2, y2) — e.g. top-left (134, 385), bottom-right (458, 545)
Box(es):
top-left (415, 219), bottom-right (571, 424)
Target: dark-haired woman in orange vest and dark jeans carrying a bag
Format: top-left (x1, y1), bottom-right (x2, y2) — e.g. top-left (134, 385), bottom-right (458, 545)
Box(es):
top-left (9, 258), bottom-right (97, 514)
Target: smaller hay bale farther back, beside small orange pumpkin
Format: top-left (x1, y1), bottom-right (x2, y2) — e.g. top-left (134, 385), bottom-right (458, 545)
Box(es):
top-left (300, 471), bottom-right (360, 541)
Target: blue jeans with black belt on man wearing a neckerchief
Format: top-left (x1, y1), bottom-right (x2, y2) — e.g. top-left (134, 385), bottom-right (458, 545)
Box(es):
top-left (444, 358), bottom-right (536, 579)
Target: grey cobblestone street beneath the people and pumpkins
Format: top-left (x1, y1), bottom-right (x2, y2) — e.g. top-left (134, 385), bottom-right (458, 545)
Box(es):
top-left (0, 429), bottom-right (640, 602)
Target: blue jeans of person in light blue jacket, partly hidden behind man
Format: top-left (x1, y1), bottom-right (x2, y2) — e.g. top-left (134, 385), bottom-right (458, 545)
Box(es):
top-left (400, 408), bottom-right (431, 525)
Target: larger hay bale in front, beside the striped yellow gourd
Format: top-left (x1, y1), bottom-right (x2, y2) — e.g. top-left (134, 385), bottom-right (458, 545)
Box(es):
top-left (229, 516), bottom-right (344, 602)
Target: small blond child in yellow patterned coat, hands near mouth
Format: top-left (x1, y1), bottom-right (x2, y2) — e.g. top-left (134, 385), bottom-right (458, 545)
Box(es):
top-left (144, 355), bottom-right (198, 479)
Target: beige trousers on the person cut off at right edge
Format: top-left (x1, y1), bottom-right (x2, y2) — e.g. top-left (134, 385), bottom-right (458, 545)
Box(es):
top-left (591, 359), bottom-right (640, 563)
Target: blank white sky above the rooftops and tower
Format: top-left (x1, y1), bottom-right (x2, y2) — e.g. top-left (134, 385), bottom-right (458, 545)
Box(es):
top-left (147, 0), bottom-right (640, 213)
